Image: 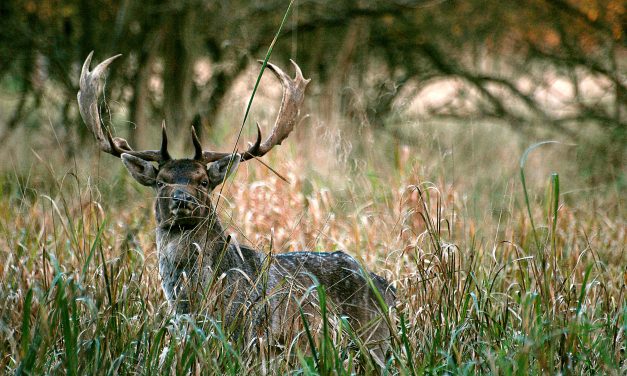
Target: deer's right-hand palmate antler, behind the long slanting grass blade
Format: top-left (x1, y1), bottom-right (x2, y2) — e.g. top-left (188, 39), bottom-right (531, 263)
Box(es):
top-left (242, 60), bottom-right (311, 161)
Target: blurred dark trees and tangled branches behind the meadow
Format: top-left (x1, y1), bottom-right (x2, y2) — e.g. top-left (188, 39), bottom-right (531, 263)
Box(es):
top-left (0, 0), bottom-right (627, 185)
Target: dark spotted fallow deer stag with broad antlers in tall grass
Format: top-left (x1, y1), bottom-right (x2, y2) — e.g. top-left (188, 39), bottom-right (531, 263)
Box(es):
top-left (78, 52), bottom-right (395, 364)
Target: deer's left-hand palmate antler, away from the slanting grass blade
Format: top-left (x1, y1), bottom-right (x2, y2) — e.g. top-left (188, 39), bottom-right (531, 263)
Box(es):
top-left (76, 51), bottom-right (169, 162)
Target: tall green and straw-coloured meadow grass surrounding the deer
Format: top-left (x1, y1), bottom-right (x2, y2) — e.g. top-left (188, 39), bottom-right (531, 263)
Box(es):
top-left (0, 90), bottom-right (627, 375)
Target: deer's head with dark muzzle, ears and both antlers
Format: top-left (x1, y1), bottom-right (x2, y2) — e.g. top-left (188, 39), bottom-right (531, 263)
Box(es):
top-left (78, 52), bottom-right (309, 227)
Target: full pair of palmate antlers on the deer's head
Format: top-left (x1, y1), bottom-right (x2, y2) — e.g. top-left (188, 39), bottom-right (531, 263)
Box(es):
top-left (77, 51), bottom-right (310, 164)
